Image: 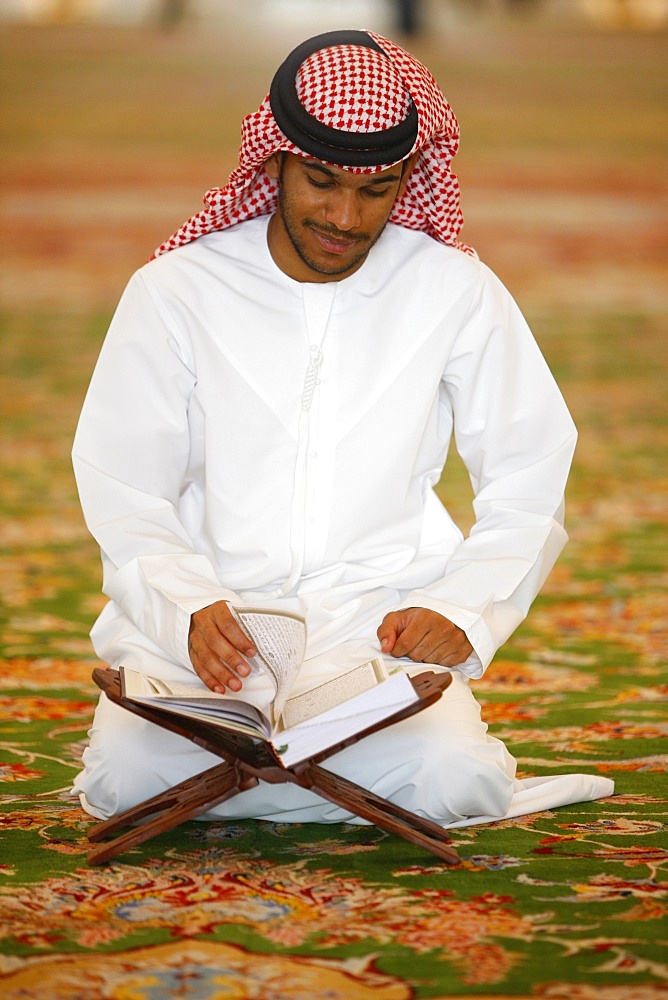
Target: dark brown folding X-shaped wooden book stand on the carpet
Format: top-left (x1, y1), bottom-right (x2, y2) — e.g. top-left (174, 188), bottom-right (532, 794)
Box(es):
top-left (88, 667), bottom-right (459, 865)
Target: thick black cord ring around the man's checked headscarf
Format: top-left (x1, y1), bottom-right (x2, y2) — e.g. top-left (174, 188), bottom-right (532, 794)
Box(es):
top-left (269, 30), bottom-right (418, 167)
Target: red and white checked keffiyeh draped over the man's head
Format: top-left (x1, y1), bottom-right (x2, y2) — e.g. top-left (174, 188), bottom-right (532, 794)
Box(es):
top-left (154, 31), bottom-right (473, 256)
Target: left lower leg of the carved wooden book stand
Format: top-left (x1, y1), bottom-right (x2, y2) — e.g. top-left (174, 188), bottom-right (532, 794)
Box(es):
top-left (88, 762), bottom-right (258, 865)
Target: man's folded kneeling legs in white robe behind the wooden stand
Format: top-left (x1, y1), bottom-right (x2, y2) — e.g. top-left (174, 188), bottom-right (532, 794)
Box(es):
top-left (74, 673), bottom-right (515, 824)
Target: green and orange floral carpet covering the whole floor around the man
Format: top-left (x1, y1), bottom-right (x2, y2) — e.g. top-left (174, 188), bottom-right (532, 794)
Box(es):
top-left (0, 13), bottom-right (668, 1000)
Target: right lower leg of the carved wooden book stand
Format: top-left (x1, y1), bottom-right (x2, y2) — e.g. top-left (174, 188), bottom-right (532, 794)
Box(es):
top-left (295, 764), bottom-right (459, 865)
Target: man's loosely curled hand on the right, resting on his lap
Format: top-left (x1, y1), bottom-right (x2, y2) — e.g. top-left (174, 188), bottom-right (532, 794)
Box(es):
top-left (377, 608), bottom-right (473, 667)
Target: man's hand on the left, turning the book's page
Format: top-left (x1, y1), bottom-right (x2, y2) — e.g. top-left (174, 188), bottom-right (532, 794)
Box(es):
top-left (188, 601), bottom-right (257, 694)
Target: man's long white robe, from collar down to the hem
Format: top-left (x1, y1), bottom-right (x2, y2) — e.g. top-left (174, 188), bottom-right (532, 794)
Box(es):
top-left (73, 223), bottom-right (612, 824)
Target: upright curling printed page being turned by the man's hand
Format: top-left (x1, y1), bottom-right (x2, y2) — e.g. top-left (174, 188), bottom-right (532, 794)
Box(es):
top-left (230, 607), bottom-right (306, 718)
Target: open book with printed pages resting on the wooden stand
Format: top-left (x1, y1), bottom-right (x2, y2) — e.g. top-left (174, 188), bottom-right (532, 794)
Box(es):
top-left (121, 608), bottom-right (419, 767)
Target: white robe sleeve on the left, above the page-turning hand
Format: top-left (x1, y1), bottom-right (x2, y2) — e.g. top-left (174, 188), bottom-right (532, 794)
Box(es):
top-left (72, 272), bottom-right (236, 665)
